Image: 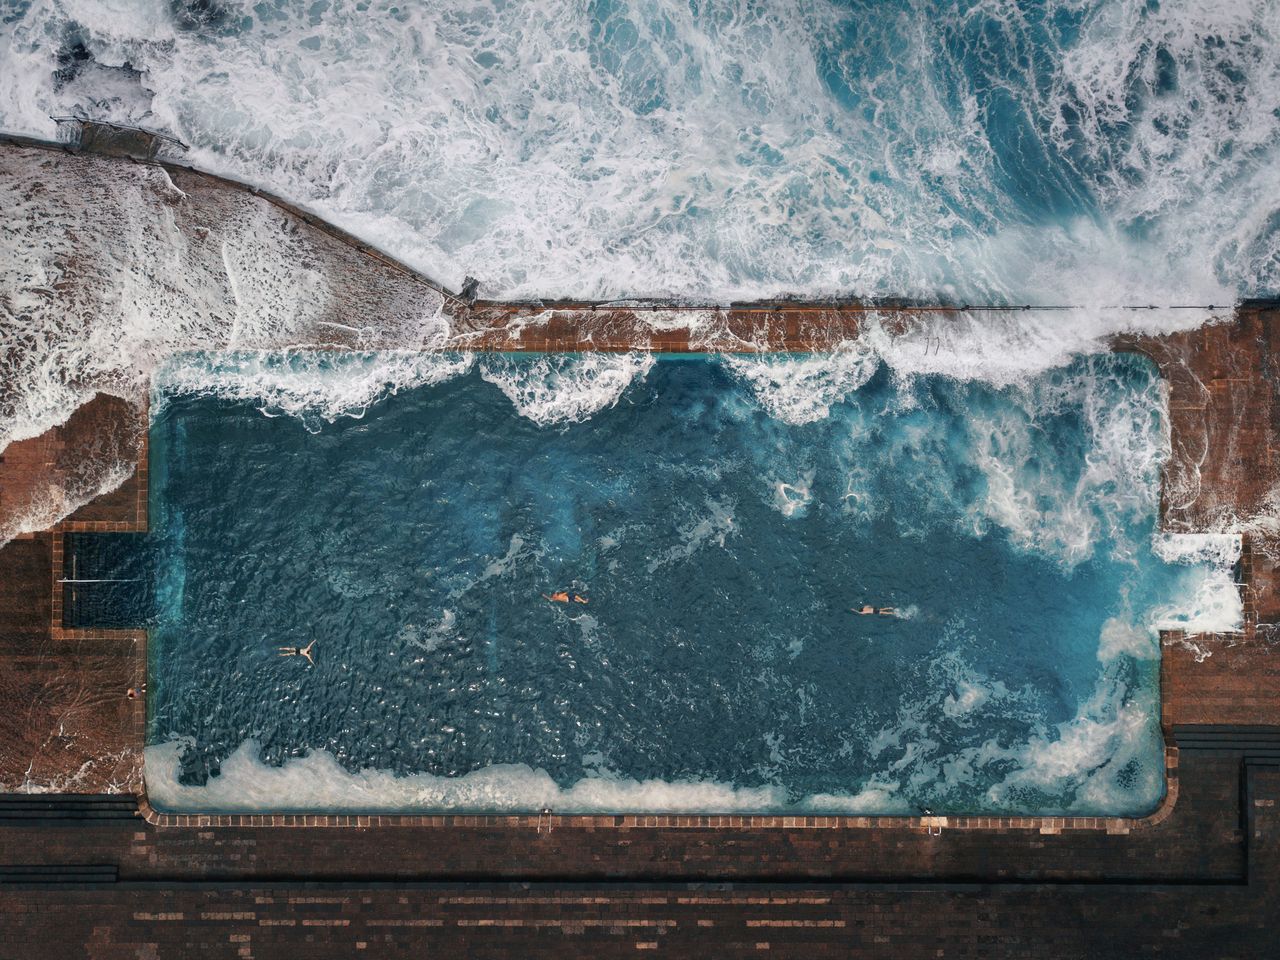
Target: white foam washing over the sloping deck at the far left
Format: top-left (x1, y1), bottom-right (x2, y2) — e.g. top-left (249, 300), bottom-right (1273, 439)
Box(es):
top-left (0, 152), bottom-right (443, 538)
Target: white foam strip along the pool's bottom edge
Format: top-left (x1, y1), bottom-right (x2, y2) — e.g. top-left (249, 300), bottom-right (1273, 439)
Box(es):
top-left (143, 727), bottom-right (1164, 815)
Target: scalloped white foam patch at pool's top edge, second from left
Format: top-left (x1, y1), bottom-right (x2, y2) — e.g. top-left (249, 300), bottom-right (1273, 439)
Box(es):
top-left (480, 352), bottom-right (655, 426)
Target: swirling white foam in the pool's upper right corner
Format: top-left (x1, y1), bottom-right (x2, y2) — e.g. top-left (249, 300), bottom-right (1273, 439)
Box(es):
top-left (815, 357), bottom-right (1169, 566)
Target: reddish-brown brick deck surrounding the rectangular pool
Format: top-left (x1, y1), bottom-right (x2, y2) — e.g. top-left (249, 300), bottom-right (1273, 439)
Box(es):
top-left (0, 133), bottom-right (1280, 960)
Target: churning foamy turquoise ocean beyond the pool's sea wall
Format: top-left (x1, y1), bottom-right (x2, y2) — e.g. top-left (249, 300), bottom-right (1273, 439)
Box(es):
top-left (0, 0), bottom-right (1280, 302)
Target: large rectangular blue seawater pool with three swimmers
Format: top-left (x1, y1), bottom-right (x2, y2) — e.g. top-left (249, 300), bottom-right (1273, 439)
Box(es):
top-left (146, 355), bottom-right (1238, 815)
